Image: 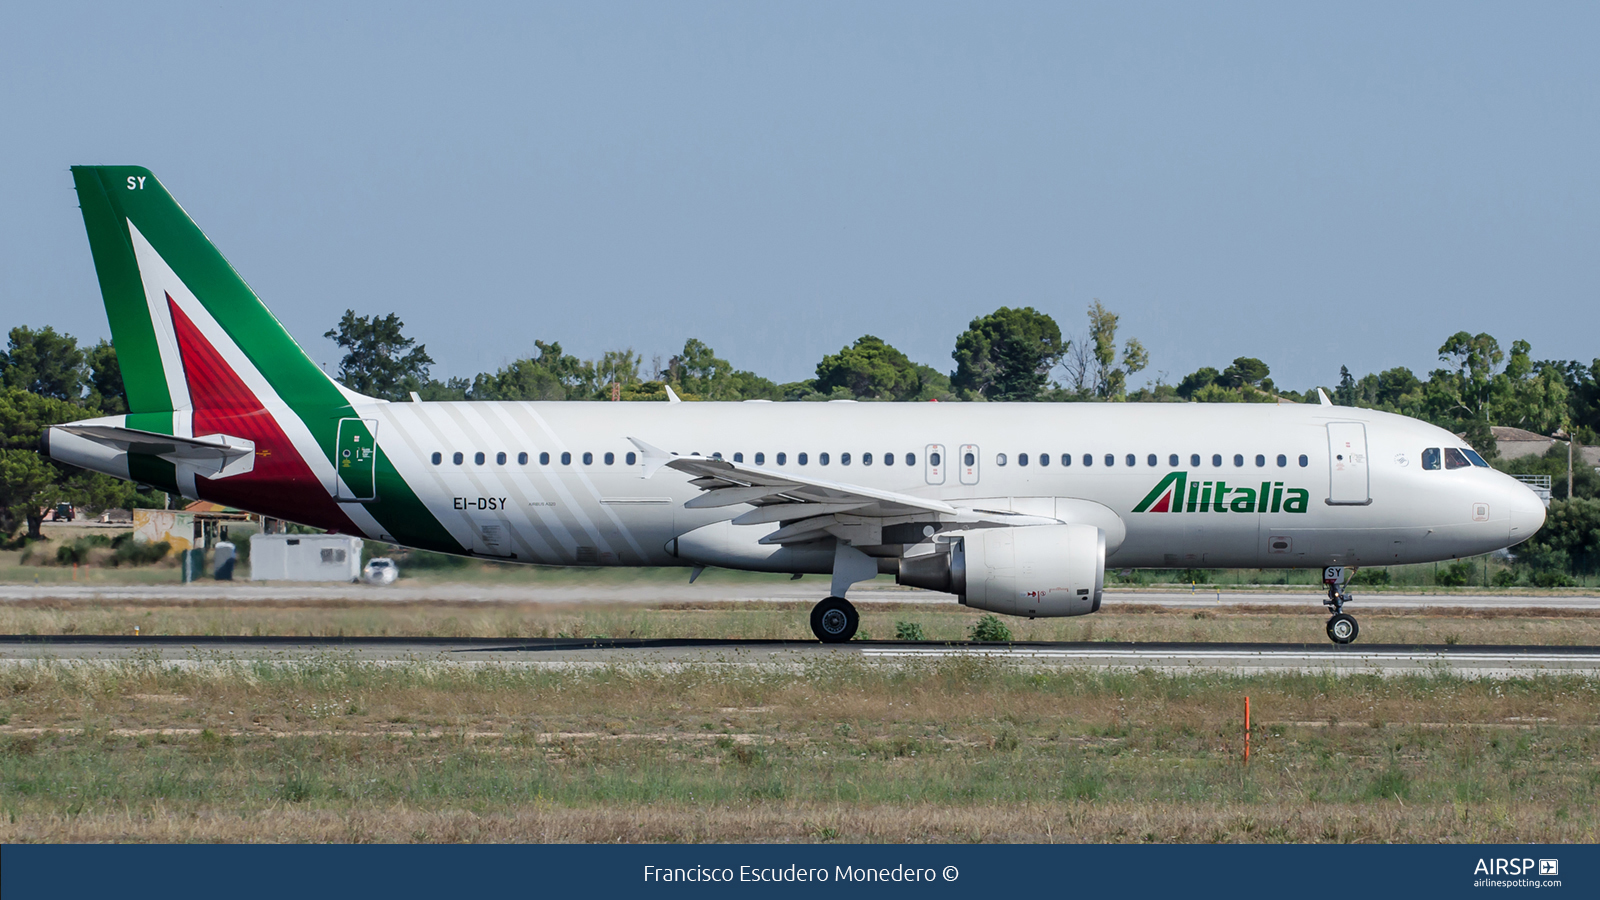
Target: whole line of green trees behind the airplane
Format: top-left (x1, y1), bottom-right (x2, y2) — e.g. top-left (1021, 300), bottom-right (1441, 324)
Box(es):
top-left (0, 301), bottom-right (1600, 570)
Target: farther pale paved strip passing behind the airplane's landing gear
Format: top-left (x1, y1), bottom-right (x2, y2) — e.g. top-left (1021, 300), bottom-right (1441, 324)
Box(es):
top-left (9, 575), bottom-right (1600, 613)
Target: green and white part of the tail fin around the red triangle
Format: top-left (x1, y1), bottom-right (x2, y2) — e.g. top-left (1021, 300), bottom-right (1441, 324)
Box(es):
top-left (72, 165), bottom-right (349, 419)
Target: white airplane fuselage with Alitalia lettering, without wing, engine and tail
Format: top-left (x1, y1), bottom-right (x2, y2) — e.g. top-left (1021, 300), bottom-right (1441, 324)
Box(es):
top-left (358, 402), bottom-right (1544, 572)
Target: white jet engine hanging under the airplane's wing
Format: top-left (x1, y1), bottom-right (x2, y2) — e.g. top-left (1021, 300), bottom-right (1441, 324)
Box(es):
top-left (894, 525), bottom-right (1106, 617)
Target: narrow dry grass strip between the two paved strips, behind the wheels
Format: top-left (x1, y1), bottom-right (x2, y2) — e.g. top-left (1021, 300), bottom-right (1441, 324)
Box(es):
top-left (0, 599), bottom-right (1600, 645)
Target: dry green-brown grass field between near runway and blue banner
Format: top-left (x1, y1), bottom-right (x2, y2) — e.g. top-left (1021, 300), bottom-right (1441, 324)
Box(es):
top-left (0, 653), bottom-right (1600, 842)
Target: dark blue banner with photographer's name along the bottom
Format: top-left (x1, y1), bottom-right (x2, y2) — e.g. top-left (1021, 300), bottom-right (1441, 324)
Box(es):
top-left (0, 844), bottom-right (1600, 900)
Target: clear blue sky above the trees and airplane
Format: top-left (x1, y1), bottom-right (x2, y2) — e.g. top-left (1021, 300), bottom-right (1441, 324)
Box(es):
top-left (0, 2), bottom-right (1600, 389)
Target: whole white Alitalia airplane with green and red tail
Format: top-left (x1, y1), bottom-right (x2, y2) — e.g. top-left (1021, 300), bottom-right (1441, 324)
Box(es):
top-left (42, 167), bottom-right (1544, 644)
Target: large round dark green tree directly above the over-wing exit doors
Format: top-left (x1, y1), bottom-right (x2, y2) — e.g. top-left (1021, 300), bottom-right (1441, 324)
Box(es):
top-left (950, 306), bottom-right (1067, 400)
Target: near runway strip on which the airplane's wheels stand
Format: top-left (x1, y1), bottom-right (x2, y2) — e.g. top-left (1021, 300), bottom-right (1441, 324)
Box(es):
top-left (0, 636), bottom-right (1600, 677)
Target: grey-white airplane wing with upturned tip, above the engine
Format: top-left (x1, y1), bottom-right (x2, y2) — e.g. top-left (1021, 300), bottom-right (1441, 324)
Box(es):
top-left (629, 439), bottom-right (1054, 544)
